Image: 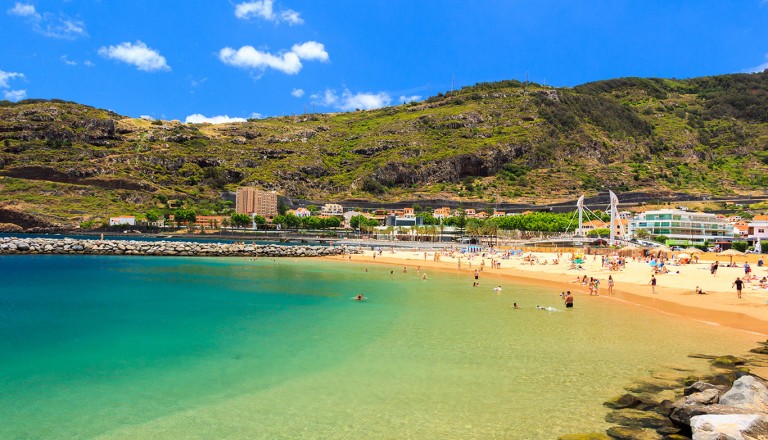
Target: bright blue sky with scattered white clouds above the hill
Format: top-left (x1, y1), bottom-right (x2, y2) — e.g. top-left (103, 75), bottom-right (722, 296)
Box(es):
top-left (0, 0), bottom-right (768, 122)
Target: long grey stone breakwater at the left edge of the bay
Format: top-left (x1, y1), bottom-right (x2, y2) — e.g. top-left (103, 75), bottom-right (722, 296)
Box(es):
top-left (0, 237), bottom-right (359, 257)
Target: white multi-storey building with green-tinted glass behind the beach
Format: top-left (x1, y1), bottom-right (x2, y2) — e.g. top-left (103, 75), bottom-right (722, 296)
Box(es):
top-left (628, 209), bottom-right (733, 244)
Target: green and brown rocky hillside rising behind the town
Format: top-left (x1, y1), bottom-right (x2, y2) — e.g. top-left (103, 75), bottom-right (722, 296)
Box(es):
top-left (0, 72), bottom-right (768, 224)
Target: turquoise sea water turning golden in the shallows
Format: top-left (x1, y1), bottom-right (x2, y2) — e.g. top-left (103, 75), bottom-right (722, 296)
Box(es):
top-left (0, 256), bottom-right (751, 439)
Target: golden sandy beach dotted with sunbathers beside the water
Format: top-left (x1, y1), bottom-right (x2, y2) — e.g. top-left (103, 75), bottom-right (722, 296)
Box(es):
top-left (326, 249), bottom-right (768, 341)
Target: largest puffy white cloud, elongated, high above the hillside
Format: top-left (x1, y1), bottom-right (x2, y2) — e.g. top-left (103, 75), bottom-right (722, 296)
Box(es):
top-left (219, 41), bottom-right (328, 75)
